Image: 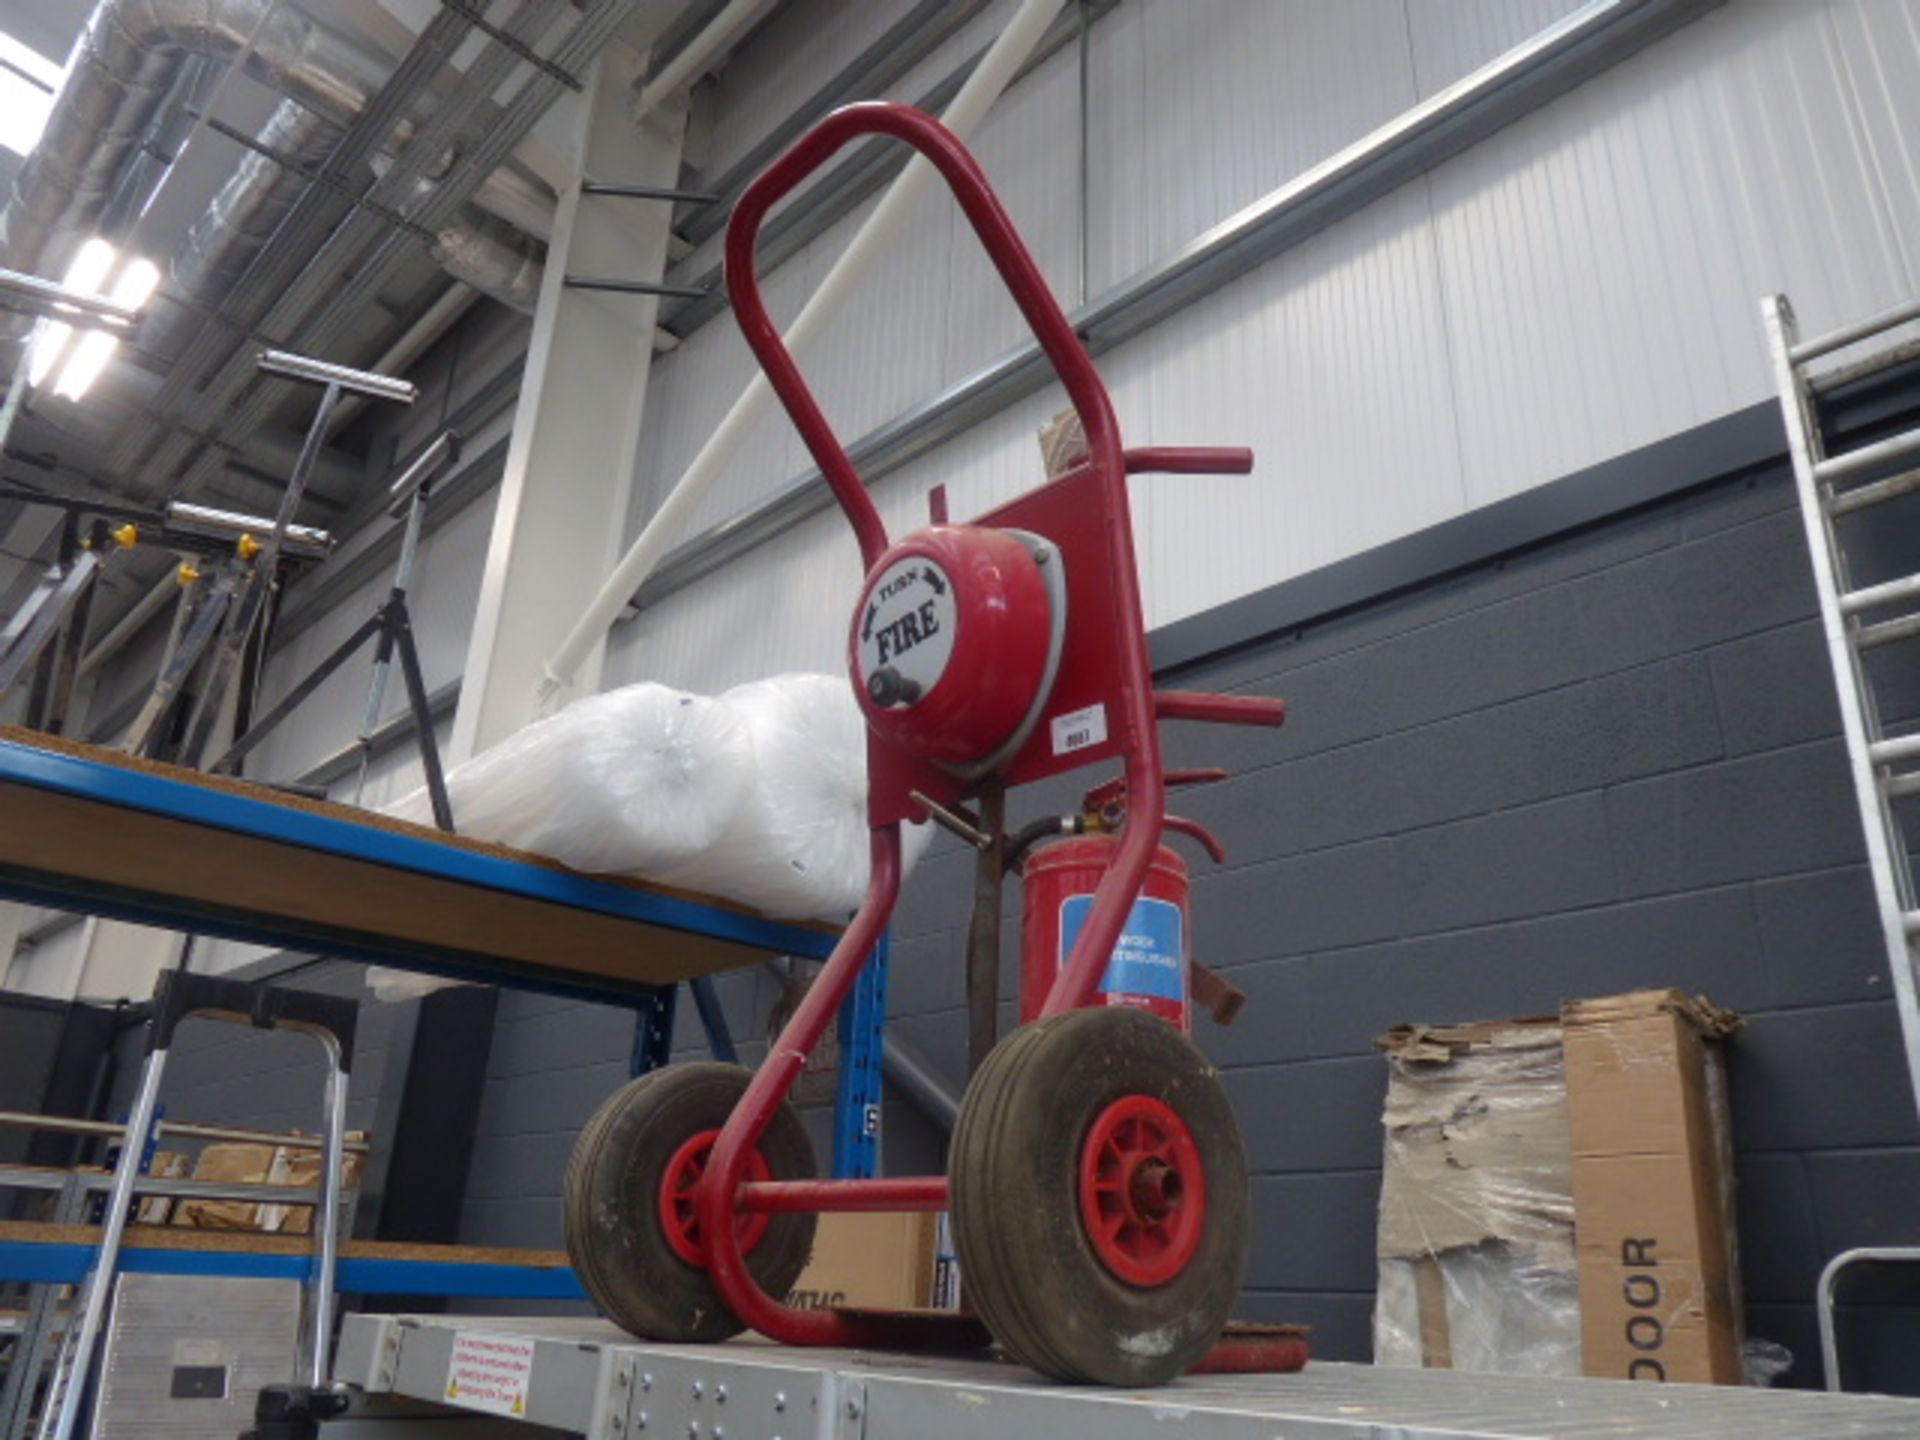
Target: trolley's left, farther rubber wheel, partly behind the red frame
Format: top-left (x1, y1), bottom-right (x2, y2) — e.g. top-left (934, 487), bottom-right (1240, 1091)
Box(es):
top-left (563, 1062), bottom-right (814, 1342)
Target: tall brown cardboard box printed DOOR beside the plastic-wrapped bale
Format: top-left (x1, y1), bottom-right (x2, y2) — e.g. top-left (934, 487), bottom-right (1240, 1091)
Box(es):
top-left (1561, 991), bottom-right (1741, 1384)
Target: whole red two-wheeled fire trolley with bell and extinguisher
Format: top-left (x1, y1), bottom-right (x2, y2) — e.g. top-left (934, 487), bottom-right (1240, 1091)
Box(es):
top-left (566, 104), bottom-right (1306, 1386)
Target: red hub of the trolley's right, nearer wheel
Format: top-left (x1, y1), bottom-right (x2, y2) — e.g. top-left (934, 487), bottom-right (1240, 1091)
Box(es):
top-left (1079, 1094), bottom-right (1206, 1288)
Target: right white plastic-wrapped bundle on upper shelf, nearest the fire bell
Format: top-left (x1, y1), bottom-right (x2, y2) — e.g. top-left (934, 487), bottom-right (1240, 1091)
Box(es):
top-left (657, 674), bottom-right (927, 920)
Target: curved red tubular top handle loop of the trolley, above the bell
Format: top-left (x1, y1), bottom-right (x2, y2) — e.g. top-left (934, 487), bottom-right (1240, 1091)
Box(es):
top-left (726, 102), bottom-right (1125, 566)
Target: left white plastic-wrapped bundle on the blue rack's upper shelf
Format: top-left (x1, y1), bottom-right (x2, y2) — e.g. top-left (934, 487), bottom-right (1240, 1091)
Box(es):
top-left (388, 684), bottom-right (755, 876)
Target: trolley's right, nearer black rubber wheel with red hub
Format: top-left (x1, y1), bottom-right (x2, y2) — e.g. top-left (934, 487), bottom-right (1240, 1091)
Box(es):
top-left (948, 1006), bottom-right (1250, 1386)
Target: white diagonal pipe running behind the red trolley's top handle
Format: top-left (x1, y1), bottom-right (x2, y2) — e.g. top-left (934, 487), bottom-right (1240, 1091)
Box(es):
top-left (540, 0), bottom-right (1066, 705)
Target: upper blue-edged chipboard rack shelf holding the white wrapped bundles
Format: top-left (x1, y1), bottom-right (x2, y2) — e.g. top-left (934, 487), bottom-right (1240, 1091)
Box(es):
top-left (0, 728), bottom-right (839, 1000)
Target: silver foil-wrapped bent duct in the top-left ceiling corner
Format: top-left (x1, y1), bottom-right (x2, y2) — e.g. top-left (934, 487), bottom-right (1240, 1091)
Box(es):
top-left (0, 0), bottom-right (384, 275)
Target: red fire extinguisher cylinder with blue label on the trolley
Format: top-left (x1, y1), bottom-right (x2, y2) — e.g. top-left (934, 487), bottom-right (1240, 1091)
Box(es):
top-left (1020, 835), bottom-right (1192, 1033)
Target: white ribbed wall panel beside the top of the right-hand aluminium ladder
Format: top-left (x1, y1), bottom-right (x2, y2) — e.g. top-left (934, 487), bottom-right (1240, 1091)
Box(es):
top-left (1430, 0), bottom-right (1920, 505)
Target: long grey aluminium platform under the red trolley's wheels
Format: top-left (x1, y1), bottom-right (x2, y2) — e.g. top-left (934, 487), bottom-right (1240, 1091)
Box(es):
top-left (334, 1315), bottom-right (1920, 1440)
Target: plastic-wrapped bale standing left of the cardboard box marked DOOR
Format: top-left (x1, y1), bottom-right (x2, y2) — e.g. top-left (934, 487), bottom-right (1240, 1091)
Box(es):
top-left (1373, 1020), bottom-right (1580, 1375)
